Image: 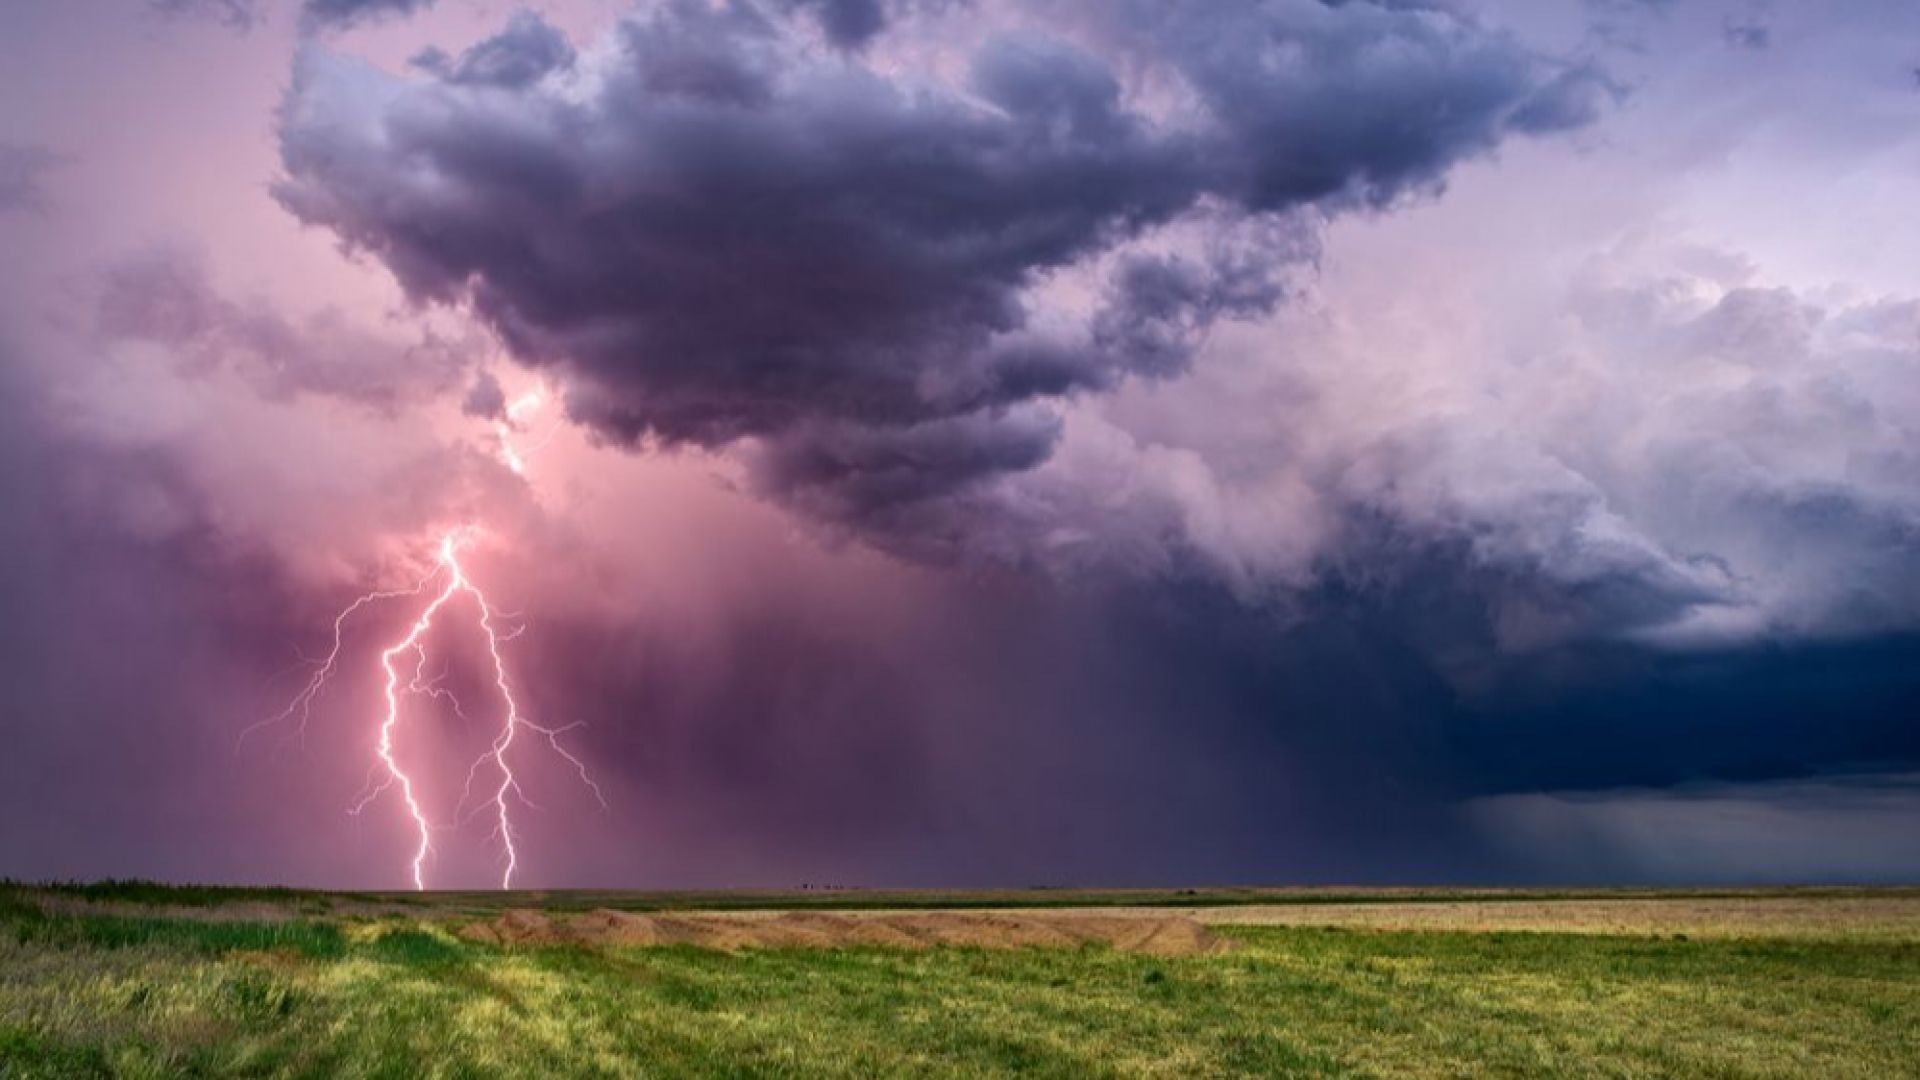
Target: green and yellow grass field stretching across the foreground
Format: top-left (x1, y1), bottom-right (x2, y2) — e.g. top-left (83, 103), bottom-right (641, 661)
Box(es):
top-left (0, 884), bottom-right (1920, 1080)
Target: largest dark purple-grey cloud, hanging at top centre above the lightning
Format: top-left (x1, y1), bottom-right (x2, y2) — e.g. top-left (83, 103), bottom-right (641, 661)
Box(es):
top-left (276, 0), bottom-right (1605, 549)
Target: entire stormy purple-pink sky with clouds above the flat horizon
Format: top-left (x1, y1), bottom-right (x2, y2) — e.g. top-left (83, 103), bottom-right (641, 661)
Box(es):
top-left (0, 0), bottom-right (1920, 888)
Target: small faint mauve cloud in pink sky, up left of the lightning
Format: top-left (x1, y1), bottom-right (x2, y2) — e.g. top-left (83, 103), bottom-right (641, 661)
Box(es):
top-left (96, 252), bottom-right (472, 411)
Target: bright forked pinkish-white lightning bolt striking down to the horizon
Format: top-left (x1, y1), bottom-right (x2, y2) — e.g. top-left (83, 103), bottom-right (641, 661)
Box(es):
top-left (251, 527), bottom-right (607, 890)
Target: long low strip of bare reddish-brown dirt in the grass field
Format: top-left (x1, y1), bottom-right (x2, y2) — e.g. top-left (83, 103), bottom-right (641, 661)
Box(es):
top-left (461, 909), bottom-right (1229, 957)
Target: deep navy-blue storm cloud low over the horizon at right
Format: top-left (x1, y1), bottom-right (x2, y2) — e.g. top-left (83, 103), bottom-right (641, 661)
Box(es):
top-left (1269, 525), bottom-right (1920, 799)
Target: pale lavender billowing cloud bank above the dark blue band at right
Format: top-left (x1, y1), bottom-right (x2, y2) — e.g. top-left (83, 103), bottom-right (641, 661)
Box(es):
top-left (998, 239), bottom-right (1920, 655)
